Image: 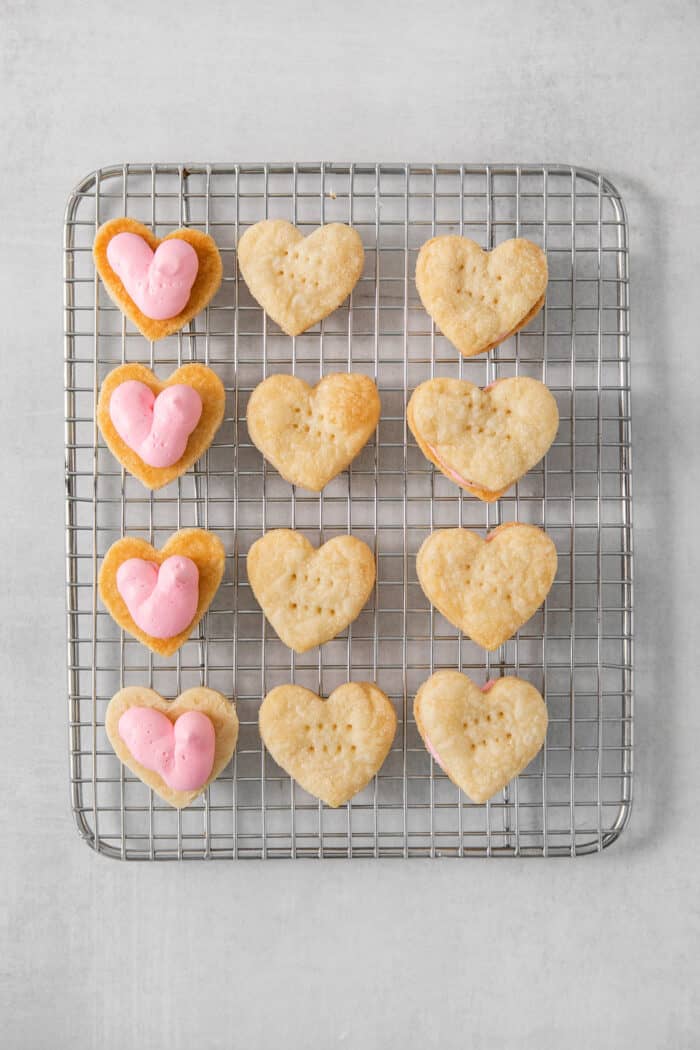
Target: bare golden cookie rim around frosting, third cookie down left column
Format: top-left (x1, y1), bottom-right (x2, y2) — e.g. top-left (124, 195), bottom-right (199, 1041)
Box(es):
top-left (98, 528), bottom-right (226, 656)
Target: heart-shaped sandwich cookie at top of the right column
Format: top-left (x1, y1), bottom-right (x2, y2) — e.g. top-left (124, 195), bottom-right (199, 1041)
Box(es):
top-left (416, 235), bottom-right (547, 357)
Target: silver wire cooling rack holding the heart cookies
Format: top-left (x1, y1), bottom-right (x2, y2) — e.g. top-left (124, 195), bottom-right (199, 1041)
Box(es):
top-left (64, 164), bottom-right (632, 860)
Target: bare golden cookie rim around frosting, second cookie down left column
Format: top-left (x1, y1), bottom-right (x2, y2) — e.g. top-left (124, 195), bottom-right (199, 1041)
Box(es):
top-left (98, 362), bottom-right (226, 489)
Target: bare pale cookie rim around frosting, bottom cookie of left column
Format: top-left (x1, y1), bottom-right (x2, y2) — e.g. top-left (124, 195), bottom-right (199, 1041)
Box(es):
top-left (105, 686), bottom-right (238, 810)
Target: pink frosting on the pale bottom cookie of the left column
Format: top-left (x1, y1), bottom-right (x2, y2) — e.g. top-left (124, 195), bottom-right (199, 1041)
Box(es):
top-left (119, 708), bottom-right (216, 791)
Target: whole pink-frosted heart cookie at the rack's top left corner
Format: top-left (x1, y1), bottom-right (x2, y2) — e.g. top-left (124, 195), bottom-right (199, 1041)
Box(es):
top-left (92, 216), bottom-right (224, 341)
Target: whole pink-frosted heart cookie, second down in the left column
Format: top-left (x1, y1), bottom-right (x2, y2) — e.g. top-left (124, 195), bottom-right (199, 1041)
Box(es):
top-left (98, 363), bottom-right (226, 489)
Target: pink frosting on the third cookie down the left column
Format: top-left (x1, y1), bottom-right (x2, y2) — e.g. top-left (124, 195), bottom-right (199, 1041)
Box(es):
top-left (116, 554), bottom-right (199, 638)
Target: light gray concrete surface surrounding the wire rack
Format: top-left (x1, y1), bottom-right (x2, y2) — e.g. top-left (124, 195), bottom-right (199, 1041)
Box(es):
top-left (0, 0), bottom-right (700, 1050)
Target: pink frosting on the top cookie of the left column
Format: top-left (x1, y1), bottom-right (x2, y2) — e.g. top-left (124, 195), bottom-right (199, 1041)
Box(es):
top-left (107, 233), bottom-right (199, 321)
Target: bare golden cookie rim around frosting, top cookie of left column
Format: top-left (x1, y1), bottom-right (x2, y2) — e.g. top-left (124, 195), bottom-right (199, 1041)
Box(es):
top-left (92, 216), bottom-right (224, 341)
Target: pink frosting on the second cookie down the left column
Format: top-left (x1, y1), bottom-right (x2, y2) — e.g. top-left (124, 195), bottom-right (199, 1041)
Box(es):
top-left (109, 379), bottom-right (201, 467)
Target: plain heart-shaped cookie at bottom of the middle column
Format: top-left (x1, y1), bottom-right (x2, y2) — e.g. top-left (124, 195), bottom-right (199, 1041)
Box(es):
top-left (259, 681), bottom-right (397, 807)
